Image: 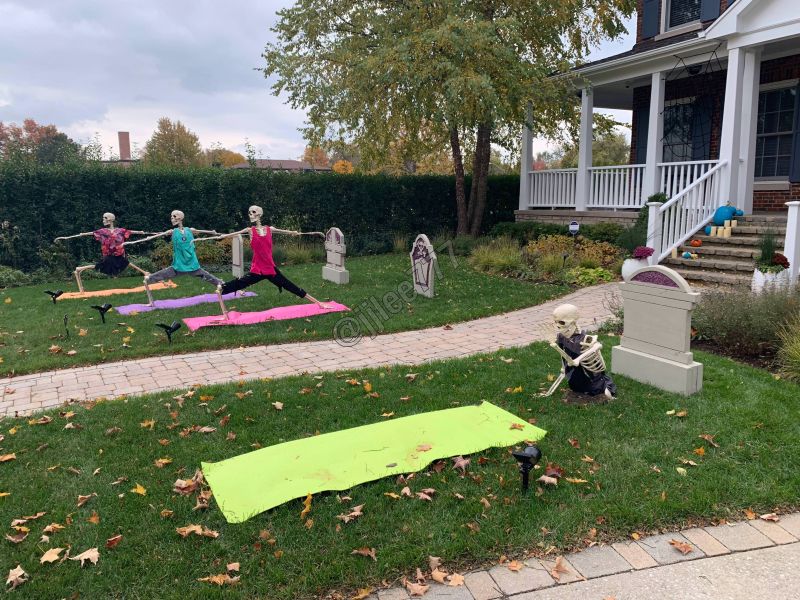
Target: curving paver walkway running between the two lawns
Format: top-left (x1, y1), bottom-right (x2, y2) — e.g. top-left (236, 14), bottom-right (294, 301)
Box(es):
top-left (0, 283), bottom-right (617, 416)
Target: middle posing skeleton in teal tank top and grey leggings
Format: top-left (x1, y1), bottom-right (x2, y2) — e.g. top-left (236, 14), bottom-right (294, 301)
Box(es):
top-left (124, 210), bottom-right (227, 314)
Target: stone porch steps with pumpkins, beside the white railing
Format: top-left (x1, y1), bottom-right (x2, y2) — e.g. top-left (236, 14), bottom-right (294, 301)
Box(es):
top-left (663, 214), bottom-right (786, 287)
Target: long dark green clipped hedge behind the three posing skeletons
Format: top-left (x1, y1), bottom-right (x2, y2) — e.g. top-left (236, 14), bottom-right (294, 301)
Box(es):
top-left (0, 163), bottom-right (519, 271)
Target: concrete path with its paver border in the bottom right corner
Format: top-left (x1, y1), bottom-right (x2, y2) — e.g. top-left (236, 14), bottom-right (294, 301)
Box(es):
top-left (369, 513), bottom-right (800, 600)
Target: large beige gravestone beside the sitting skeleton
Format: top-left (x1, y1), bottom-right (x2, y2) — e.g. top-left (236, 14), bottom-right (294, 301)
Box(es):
top-left (611, 265), bottom-right (703, 396)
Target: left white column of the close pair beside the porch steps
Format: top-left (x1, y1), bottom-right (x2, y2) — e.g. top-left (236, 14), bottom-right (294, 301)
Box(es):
top-left (719, 48), bottom-right (750, 207)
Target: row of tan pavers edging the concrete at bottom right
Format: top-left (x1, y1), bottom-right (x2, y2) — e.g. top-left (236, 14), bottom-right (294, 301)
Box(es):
top-left (376, 513), bottom-right (800, 600)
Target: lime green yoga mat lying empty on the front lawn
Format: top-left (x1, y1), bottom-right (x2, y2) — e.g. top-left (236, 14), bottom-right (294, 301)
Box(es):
top-left (202, 402), bottom-right (546, 523)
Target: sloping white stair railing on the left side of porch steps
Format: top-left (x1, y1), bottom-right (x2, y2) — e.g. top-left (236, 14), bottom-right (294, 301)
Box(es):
top-left (647, 161), bottom-right (727, 264)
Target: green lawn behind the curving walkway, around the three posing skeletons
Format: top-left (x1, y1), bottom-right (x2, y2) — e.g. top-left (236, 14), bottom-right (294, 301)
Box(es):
top-left (0, 255), bottom-right (567, 375)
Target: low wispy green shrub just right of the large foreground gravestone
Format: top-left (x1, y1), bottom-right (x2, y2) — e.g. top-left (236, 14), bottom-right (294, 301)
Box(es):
top-left (692, 287), bottom-right (800, 357)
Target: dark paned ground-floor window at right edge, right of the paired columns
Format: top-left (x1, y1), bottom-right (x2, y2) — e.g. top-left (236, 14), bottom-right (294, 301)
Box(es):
top-left (755, 87), bottom-right (797, 179)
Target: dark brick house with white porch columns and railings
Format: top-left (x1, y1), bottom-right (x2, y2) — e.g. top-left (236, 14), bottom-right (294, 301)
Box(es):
top-left (516, 0), bottom-right (800, 286)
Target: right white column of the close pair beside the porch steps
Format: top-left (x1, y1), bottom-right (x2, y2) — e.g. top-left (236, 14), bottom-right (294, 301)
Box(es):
top-left (738, 48), bottom-right (761, 214)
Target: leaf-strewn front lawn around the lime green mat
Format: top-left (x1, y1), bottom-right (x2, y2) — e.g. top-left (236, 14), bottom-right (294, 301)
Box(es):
top-left (0, 339), bottom-right (800, 600)
